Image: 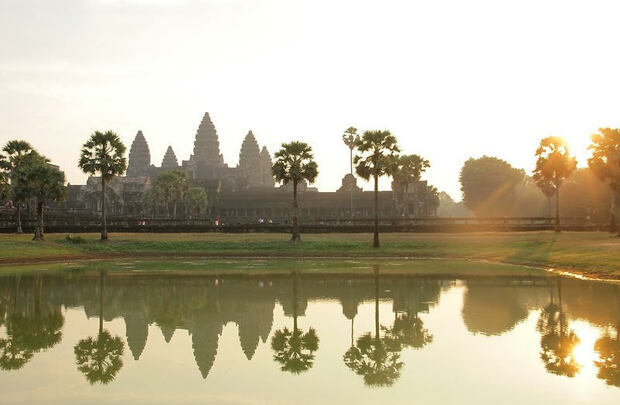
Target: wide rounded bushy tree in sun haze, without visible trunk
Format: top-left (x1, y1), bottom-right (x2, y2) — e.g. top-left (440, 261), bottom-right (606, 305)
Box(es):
top-left (459, 156), bottom-right (525, 216)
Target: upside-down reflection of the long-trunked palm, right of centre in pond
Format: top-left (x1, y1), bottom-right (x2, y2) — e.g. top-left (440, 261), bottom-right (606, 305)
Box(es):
top-left (343, 266), bottom-right (403, 387)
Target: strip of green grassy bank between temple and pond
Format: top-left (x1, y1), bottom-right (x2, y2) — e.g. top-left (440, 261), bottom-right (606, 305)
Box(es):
top-left (0, 232), bottom-right (620, 279)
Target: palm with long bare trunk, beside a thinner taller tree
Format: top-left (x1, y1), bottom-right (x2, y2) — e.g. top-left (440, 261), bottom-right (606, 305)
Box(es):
top-left (353, 131), bottom-right (400, 248)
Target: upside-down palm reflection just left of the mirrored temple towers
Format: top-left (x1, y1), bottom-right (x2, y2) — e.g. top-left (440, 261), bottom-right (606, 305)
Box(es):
top-left (73, 271), bottom-right (125, 384)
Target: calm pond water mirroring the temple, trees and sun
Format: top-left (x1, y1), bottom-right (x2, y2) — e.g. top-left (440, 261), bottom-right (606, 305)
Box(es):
top-left (0, 263), bottom-right (620, 404)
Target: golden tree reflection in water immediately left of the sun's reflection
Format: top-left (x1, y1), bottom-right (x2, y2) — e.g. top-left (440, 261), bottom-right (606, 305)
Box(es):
top-left (536, 278), bottom-right (581, 377)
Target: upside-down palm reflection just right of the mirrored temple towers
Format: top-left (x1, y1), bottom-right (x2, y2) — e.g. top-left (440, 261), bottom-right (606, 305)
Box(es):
top-left (271, 271), bottom-right (319, 374)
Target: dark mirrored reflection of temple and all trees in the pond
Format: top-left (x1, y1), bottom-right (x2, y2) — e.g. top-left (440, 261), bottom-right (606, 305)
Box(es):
top-left (0, 268), bottom-right (620, 386)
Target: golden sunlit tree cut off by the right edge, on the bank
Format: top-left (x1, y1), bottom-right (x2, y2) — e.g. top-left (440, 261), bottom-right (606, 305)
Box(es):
top-left (588, 128), bottom-right (620, 232)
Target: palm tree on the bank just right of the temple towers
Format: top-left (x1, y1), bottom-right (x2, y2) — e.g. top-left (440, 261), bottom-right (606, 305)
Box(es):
top-left (271, 141), bottom-right (319, 242)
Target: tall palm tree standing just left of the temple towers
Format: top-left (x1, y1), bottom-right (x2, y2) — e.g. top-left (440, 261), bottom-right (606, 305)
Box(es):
top-left (78, 131), bottom-right (127, 240)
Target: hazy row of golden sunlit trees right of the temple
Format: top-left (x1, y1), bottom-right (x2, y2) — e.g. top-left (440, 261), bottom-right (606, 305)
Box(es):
top-left (456, 128), bottom-right (620, 232)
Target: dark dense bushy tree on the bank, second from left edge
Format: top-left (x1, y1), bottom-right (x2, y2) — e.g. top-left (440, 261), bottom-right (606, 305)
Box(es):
top-left (11, 153), bottom-right (66, 241)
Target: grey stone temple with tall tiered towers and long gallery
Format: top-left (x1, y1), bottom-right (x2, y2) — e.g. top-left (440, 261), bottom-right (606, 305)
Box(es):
top-left (65, 113), bottom-right (438, 224)
